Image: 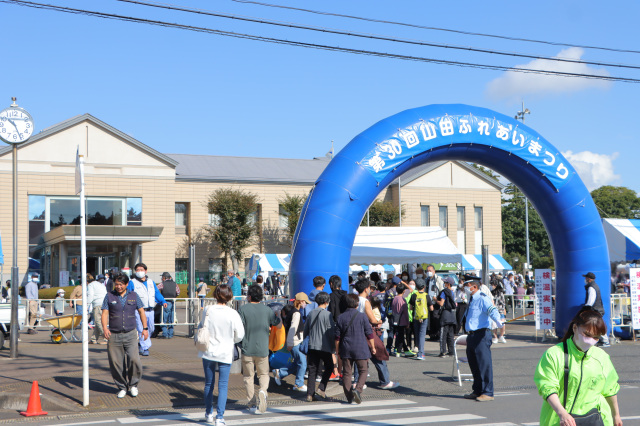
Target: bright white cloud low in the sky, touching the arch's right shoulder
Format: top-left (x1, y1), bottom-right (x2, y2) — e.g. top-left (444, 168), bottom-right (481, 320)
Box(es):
top-left (562, 151), bottom-right (620, 191)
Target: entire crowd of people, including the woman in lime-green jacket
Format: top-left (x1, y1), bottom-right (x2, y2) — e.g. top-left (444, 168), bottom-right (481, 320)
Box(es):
top-left (6, 263), bottom-right (622, 425)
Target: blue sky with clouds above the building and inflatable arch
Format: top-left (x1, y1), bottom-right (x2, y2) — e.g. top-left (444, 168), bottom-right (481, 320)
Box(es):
top-left (0, 0), bottom-right (640, 192)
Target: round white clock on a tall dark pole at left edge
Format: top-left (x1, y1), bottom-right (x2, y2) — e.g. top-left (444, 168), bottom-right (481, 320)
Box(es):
top-left (0, 98), bottom-right (33, 358)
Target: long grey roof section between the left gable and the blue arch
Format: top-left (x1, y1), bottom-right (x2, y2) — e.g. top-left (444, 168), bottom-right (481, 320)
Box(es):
top-left (167, 154), bottom-right (330, 184)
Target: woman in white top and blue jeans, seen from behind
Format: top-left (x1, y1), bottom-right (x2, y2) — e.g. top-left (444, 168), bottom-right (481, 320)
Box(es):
top-left (198, 284), bottom-right (244, 426)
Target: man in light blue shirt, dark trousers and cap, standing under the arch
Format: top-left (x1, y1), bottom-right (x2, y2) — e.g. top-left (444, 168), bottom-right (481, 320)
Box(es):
top-left (464, 280), bottom-right (502, 402)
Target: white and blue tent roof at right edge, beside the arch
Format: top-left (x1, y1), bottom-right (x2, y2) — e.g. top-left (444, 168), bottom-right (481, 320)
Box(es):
top-left (602, 219), bottom-right (640, 262)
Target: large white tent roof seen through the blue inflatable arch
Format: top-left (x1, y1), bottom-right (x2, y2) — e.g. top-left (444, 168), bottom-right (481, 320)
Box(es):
top-left (350, 226), bottom-right (462, 264)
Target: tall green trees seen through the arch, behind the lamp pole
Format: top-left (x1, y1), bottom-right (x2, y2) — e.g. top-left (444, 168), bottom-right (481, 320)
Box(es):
top-left (502, 183), bottom-right (553, 270)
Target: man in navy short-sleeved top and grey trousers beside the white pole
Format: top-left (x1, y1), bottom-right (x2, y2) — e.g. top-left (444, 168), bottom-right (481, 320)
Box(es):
top-left (101, 274), bottom-right (149, 398)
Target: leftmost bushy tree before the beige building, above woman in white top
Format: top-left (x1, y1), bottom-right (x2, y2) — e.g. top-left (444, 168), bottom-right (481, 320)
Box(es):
top-left (207, 188), bottom-right (258, 271)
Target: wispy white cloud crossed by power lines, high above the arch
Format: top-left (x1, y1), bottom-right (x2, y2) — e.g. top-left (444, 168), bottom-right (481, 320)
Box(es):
top-left (487, 47), bottom-right (611, 99)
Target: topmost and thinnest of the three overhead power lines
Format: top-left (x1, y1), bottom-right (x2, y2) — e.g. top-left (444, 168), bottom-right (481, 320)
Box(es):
top-left (232, 0), bottom-right (640, 53)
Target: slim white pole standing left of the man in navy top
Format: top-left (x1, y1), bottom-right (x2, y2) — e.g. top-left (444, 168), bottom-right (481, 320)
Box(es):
top-left (76, 148), bottom-right (89, 407)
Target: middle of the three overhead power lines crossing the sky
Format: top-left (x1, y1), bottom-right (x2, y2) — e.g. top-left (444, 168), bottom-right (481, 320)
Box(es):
top-left (116, 0), bottom-right (640, 70)
